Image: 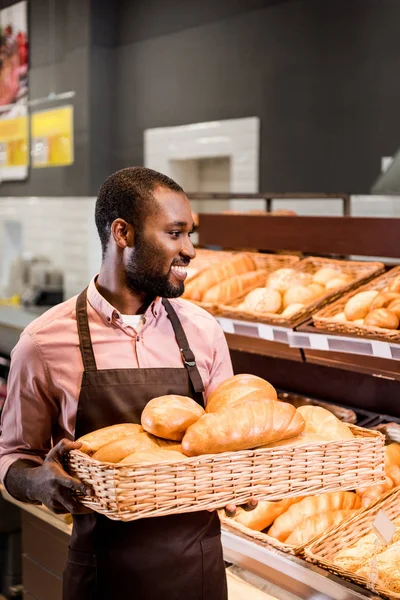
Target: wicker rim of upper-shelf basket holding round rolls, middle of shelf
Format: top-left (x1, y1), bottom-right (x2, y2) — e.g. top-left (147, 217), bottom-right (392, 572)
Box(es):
top-left (218, 256), bottom-right (385, 327)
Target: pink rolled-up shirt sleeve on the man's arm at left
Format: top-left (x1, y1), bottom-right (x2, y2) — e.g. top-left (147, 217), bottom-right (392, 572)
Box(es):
top-left (0, 332), bottom-right (58, 482)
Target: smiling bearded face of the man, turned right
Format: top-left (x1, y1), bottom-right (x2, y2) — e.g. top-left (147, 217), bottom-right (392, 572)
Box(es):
top-left (125, 187), bottom-right (196, 298)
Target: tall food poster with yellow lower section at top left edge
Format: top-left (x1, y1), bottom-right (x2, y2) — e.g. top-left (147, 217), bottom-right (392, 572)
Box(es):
top-left (0, 0), bottom-right (29, 182)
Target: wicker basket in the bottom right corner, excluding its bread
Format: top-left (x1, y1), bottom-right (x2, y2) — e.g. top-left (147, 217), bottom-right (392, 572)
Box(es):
top-left (304, 487), bottom-right (400, 598)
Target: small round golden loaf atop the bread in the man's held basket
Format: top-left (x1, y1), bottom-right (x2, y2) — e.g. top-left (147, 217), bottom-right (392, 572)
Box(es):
top-left (141, 395), bottom-right (204, 441)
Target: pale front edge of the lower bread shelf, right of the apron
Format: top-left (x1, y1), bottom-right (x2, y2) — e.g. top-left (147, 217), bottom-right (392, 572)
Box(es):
top-left (222, 531), bottom-right (378, 600)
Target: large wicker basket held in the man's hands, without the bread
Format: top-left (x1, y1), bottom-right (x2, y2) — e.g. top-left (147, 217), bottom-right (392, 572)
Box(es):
top-left (69, 425), bottom-right (384, 521)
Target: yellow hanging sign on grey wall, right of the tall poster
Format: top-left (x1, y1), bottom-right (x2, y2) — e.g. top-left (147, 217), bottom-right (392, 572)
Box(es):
top-left (31, 106), bottom-right (74, 167)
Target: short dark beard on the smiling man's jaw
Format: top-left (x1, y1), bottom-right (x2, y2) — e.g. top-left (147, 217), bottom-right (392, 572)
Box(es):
top-left (125, 236), bottom-right (185, 298)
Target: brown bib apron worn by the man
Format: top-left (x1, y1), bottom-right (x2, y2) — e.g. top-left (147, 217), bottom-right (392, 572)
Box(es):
top-left (63, 290), bottom-right (227, 600)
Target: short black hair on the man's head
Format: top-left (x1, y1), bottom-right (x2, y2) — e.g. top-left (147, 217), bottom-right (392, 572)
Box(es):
top-left (95, 167), bottom-right (183, 258)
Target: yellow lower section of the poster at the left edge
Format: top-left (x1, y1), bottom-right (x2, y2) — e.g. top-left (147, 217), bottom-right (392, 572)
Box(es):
top-left (0, 116), bottom-right (29, 167)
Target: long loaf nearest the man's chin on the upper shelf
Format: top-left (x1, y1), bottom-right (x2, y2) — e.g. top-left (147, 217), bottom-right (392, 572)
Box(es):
top-left (183, 252), bottom-right (257, 301)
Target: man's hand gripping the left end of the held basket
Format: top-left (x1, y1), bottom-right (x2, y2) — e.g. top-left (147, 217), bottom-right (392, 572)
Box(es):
top-left (28, 439), bottom-right (92, 514)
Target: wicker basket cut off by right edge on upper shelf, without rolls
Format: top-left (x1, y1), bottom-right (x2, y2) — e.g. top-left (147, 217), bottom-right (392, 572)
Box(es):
top-left (313, 267), bottom-right (400, 344)
